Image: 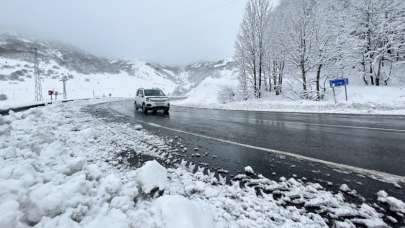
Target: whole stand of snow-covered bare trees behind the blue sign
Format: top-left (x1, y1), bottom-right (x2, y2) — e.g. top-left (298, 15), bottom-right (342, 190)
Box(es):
top-left (235, 0), bottom-right (405, 100)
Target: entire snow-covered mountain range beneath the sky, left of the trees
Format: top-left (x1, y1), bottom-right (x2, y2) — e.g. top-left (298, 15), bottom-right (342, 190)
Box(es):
top-left (0, 35), bottom-right (236, 106)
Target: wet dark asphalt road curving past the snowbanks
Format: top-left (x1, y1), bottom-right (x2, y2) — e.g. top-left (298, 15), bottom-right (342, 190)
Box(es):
top-left (88, 100), bottom-right (405, 205)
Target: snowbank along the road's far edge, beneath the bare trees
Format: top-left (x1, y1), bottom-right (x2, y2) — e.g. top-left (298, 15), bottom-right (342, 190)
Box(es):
top-left (176, 82), bottom-right (405, 115)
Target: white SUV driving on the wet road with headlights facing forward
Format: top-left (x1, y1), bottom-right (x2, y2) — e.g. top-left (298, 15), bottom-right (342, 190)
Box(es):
top-left (134, 89), bottom-right (170, 114)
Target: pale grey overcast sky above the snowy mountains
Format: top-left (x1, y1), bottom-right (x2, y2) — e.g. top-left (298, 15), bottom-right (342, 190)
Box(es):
top-left (0, 0), bottom-right (247, 64)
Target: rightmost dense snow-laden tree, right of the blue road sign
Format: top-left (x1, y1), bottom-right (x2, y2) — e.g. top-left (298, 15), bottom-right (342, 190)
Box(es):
top-left (349, 0), bottom-right (405, 86)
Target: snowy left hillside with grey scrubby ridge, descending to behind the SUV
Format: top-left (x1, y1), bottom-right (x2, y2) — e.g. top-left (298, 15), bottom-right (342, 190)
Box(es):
top-left (0, 35), bottom-right (176, 107)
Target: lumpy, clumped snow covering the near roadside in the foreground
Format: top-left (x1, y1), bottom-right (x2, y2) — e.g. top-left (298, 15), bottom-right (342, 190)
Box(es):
top-left (0, 101), bottom-right (404, 228)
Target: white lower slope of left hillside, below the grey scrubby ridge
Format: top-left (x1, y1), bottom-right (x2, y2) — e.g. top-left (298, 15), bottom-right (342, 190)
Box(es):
top-left (0, 57), bottom-right (176, 105)
